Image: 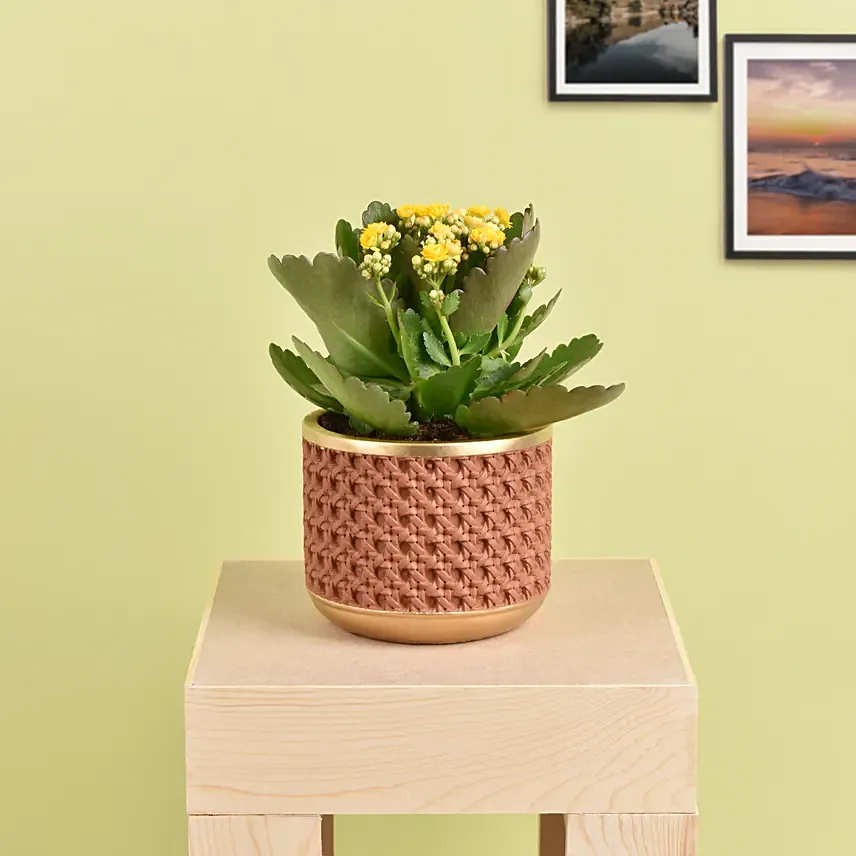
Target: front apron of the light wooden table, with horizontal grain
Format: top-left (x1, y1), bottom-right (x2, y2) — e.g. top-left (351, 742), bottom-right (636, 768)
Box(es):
top-left (186, 686), bottom-right (696, 814)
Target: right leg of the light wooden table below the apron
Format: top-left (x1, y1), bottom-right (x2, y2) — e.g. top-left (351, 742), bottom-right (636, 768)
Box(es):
top-left (565, 814), bottom-right (698, 856)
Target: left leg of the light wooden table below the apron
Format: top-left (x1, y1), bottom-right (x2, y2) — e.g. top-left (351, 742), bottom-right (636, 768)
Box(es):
top-left (188, 815), bottom-right (320, 856)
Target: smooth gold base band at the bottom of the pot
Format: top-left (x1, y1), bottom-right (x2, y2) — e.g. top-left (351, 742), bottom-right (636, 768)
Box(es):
top-left (309, 592), bottom-right (545, 645)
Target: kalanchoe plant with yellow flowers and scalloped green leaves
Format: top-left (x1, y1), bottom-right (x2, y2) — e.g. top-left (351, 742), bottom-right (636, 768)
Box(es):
top-left (269, 202), bottom-right (624, 437)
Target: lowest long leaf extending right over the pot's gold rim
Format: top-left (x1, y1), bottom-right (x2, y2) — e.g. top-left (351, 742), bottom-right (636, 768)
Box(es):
top-left (455, 383), bottom-right (624, 437)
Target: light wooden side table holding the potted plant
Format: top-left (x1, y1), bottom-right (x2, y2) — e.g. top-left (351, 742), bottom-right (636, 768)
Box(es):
top-left (185, 559), bottom-right (697, 856)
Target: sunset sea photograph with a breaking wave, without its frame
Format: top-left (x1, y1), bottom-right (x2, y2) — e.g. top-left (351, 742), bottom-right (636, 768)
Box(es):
top-left (746, 59), bottom-right (856, 235)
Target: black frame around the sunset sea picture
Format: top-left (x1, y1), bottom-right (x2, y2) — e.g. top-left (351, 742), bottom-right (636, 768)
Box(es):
top-left (723, 33), bottom-right (856, 261)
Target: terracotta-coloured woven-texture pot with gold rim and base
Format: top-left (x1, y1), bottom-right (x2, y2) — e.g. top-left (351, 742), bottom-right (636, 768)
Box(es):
top-left (303, 411), bottom-right (552, 643)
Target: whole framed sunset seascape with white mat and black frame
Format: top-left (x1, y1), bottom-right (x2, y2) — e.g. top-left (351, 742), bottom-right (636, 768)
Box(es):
top-left (725, 35), bottom-right (856, 259)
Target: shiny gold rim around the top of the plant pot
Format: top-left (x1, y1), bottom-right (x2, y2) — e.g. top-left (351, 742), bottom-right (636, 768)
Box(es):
top-left (303, 410), bottom-right (553, 458)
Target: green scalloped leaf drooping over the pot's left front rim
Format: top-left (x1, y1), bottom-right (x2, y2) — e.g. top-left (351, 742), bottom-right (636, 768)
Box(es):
top-left (294, 339), bottom-right (419, 437)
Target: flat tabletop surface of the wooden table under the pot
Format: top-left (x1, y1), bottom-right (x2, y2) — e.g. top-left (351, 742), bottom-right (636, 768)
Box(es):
top-left (188, 559), bottom-right (693, 687)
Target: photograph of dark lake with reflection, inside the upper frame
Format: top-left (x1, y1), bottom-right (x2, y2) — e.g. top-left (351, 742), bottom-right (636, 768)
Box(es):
top-left (564, 0), bottom-right (700, 86)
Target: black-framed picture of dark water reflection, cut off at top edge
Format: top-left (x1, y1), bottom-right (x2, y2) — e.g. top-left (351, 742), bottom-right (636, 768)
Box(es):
top-left (547, 0), bottom-right (717, 101)
